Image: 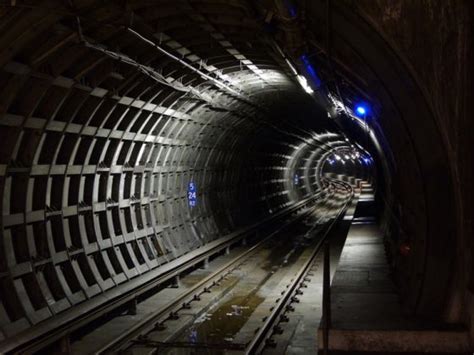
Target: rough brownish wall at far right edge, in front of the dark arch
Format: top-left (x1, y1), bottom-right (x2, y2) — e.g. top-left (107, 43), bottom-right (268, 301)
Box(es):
top-left (352, 1), bottom-right (474, 326)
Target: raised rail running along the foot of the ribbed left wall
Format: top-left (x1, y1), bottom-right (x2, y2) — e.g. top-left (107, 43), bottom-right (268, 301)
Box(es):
top-left (0, 189), bottom-right (328, 354)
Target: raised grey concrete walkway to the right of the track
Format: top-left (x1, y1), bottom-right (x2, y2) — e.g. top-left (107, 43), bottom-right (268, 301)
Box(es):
top-left (318, 186), bottom-right (470, 354)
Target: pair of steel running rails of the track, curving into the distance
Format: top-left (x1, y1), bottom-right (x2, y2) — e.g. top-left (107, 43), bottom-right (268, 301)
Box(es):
top-left (92, 181), bottom-right (353, 354)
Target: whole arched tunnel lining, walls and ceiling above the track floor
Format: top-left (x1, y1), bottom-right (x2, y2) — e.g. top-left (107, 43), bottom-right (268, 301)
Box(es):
top-left (0, 0), bottom-right (474, 353)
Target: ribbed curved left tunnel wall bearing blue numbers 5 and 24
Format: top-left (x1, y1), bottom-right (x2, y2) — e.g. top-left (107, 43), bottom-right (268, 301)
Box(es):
top-left (0, 2), bottom-right (362, 339)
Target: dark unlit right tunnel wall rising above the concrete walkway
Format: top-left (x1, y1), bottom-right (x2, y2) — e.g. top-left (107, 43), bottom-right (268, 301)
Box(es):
top-left (305, 1), bottom-right (472, 322)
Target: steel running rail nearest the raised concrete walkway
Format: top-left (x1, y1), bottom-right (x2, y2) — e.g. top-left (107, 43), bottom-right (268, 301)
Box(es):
top-left (245, 184), bottom-right (354, 355)
